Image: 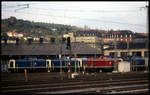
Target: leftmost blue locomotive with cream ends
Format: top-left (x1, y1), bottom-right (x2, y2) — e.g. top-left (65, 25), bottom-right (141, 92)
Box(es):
top-left (8, 58), bottom-right (51, 72)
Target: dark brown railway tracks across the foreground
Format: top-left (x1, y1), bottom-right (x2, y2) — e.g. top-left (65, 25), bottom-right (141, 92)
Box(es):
top-left (1, 73), bottom-right (149, 94)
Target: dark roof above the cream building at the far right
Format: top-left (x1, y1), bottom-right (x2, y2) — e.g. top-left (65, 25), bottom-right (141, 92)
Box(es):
top-left (105, 42), bottom-right (148, 50)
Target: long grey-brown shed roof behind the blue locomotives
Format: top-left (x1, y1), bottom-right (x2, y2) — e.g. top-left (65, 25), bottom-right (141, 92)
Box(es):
top-left (1, 43), bottom-right (101, 55)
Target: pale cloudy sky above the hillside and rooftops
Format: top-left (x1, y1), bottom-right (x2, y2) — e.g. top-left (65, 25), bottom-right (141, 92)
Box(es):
top-left (1, 1), bottom-right (148, 33)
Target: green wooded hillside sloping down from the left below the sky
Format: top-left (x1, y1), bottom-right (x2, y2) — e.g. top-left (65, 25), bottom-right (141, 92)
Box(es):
top-left (1, 17), bottom-right (79, 39)
